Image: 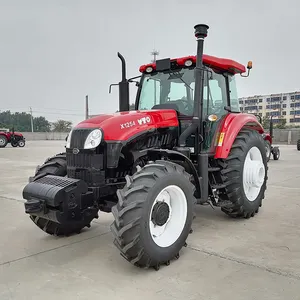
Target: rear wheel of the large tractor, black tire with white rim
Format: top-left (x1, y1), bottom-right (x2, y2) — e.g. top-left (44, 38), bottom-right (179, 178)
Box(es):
top-left (220, 130), bottom-right (268, 218)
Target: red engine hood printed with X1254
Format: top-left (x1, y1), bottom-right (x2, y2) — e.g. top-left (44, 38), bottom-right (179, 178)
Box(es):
top-left (76, 109), bottom-right (179, 141)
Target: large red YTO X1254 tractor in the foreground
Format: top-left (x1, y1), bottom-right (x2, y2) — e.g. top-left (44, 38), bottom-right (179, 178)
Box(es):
top-left (23, 24), bottom-right (268, 270)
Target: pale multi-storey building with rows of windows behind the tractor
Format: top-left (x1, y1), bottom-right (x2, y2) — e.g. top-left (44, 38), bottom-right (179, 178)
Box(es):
top-left (239, 92), bottom-right (300, 125)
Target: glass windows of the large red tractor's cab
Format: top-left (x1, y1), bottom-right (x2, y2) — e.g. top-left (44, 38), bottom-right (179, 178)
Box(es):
top-left (138, 69), bottom-right (239, 116)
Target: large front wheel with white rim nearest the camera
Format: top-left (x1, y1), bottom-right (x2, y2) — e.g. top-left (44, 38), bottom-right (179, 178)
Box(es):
top-left (111, 160), bottom-right (196, 269)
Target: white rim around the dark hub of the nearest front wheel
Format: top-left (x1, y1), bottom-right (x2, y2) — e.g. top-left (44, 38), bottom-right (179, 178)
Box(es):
top-left (149, 185), bottom-right (187, 248)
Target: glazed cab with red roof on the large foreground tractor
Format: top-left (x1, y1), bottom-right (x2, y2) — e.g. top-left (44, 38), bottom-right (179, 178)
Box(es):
top-left (135, 55), bottom-right (251, 152)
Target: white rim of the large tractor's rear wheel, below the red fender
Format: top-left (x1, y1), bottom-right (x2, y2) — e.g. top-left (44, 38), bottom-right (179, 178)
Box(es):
top-left (243, 147), bottom-right (266, 202)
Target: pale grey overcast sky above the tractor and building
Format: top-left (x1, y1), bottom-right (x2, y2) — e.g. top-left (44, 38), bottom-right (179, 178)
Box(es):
top-left (0, 0), bottom-right (300, 123)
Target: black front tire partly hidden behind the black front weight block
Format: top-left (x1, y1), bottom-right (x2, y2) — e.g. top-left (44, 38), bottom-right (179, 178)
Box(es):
top-left (30, 153), bottom-right (93, 236)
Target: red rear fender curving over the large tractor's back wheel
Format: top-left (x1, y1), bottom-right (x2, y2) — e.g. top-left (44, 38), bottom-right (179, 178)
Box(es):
top-left (215, 113), bottom-right (264, 158)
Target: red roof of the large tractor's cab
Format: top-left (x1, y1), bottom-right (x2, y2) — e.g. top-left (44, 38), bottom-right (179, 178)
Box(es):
top-left (139, 54), bottom-right (246, 74)
